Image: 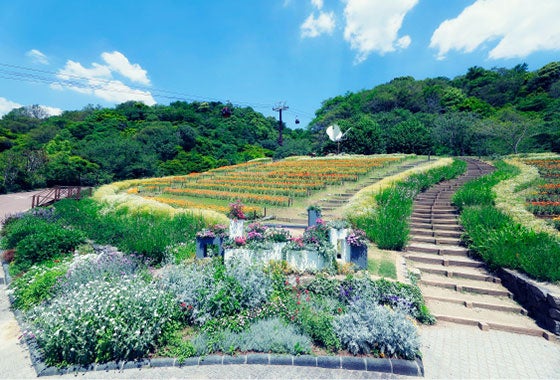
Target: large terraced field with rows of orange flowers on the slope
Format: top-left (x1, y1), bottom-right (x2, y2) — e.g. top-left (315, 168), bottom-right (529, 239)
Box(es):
top-left (128, 156), bottom-right (403, 214)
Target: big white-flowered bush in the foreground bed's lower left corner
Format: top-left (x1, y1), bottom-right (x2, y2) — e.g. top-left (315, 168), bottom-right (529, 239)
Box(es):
top-left (24, 275), bottom-right (179, 365)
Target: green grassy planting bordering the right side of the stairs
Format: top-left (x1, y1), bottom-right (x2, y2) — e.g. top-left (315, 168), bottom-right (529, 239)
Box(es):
top-left (453, 161), bottom-right (560, 281)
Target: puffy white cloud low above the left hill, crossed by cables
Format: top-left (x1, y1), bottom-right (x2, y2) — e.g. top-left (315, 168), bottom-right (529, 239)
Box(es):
top-left (51, 51), bottom-right (156, 106)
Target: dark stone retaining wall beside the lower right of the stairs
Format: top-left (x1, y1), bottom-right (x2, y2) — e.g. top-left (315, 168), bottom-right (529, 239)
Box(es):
top-left (498, 268), bottom-right (560, 335)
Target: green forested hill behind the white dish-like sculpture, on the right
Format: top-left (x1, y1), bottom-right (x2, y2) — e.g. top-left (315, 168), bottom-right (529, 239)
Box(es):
top-left (311, 62), bottom-right (560, 155)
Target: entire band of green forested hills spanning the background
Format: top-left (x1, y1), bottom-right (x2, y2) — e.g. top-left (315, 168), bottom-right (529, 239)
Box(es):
top-left (0, 62), bottom-right (560, 192)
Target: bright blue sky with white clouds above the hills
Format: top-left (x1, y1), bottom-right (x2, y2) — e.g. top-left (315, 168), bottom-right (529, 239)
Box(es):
top-left (0, 0), bottom-right (560, 127)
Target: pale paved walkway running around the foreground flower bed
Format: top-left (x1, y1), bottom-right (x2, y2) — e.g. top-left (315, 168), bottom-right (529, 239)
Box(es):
top-left (0, 186), bottom-right (560, 379)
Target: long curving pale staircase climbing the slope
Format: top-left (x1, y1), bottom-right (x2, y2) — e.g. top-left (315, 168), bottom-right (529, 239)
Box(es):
top-left (405, 159), bottom-right (550, 337)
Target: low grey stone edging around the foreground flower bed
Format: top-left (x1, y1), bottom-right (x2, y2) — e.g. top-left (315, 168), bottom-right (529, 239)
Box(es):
top-left (2, 263), bottom-right (424, 377)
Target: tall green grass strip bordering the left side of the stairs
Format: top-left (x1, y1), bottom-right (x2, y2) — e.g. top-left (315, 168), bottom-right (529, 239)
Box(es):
top-left (350, 160), bottom-right (467, 251)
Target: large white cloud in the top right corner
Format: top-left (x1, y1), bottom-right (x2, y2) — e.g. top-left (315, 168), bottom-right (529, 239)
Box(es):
top-left (430, 0), bottom-right (560, 59)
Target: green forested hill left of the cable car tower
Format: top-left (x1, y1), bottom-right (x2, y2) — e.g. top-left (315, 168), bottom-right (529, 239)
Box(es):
top-left (0, 102), bottom-right (311, 192)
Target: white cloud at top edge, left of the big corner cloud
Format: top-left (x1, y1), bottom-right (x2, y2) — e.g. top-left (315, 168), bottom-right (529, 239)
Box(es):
top-left (344, 0), bottom-right (418, 63)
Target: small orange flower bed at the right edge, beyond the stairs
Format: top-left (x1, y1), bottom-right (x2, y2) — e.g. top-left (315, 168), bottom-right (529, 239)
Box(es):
top-left (525, 158), bottom-right (560, 229)
